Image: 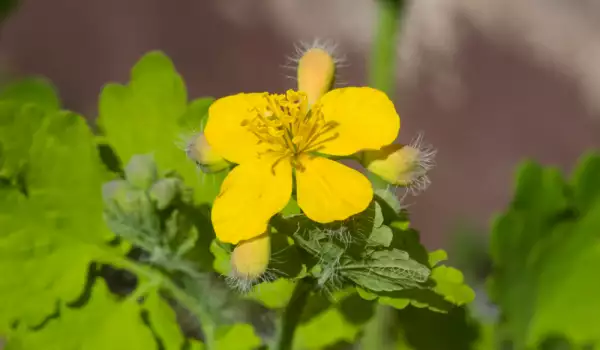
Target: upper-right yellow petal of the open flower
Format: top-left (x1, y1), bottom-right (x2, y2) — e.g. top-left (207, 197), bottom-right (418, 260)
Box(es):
top-left (317, 87), bottom-right (400, 156)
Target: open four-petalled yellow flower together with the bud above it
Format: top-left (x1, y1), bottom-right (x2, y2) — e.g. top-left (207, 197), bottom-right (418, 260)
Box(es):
top-left (204, 49), bottom-right (400, 244)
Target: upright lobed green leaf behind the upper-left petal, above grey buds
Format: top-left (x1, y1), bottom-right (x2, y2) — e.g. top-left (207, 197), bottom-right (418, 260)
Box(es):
top-left (98, 52), bottom-right (226, 203)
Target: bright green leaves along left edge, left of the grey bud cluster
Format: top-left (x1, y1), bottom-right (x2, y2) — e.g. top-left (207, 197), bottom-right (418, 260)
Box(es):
top-left (0, 79), bottom-right (203, 349)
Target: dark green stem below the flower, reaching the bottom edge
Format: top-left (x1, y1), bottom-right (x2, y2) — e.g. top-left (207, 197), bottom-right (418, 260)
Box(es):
top-left (272, 278), bottom-right (314, 350)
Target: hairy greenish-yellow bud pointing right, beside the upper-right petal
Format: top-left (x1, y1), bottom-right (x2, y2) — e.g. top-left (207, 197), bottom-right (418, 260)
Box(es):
top-left (361, 137), bottom-right (436, 192)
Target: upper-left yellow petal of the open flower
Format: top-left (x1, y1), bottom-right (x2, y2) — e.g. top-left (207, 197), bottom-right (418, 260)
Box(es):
top-left (204, 93), bottom-right (265, 164)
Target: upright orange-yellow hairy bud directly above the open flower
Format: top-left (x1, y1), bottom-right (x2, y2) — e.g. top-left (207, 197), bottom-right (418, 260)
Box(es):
top-left (298, 47), bottom-right (335, 105)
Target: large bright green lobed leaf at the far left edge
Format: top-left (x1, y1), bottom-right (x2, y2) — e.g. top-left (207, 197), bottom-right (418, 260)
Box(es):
top-left (0, 112), bottom-right (115, 329)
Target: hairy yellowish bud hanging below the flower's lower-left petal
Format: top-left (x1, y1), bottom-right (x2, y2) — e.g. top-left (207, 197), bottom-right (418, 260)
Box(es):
top-left (231, 233), bottom-right (271, 290)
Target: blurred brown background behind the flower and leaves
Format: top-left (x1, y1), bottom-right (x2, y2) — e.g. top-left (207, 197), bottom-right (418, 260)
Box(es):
top-left (0, 0), bottom-right (600, 248)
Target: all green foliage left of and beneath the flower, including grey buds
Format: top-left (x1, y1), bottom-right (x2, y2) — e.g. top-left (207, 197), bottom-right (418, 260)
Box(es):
top-left (0, 52), bottom-right (478, 350)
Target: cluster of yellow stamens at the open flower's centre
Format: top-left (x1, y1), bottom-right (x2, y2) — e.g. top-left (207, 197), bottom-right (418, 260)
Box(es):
top-left (242, 90), bottom-right (338, 158)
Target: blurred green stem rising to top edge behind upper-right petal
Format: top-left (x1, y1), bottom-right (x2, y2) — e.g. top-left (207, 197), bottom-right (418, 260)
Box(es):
top-left (369, 0), bottom-right (404, 97)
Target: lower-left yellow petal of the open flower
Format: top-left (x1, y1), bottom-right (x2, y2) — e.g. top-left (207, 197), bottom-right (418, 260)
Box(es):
top-left (211, 155), bottom-right (292, 244)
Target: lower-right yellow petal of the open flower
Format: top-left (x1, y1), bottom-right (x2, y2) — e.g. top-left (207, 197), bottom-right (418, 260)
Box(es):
top-left (296, 156), bottom-right (373, 223)
